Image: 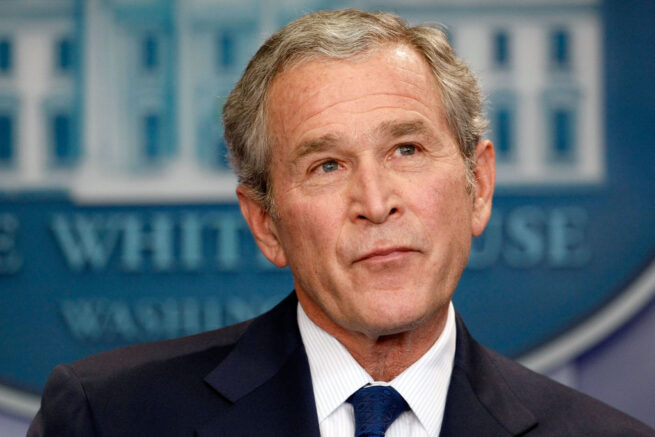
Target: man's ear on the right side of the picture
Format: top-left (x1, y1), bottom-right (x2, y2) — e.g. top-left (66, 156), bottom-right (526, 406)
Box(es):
top-left (471, 140), bottom-right (496, 237)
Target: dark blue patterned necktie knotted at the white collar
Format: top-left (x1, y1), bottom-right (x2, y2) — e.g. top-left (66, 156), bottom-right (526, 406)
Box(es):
top-left (348, 385), bottom-right (409, 437)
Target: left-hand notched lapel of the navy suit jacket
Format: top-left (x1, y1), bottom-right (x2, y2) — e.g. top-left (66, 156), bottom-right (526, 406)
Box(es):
top-left (198, 294), bottom-right (319, 437)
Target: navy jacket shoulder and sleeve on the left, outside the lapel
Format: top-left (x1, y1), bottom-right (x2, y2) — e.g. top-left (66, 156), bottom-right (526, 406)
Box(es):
top-left (28, 316), bottom-right (250, 437)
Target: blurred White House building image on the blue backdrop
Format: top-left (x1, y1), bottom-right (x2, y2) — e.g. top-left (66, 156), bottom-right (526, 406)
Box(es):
top-left (0, 0), bottom-right (605, 203)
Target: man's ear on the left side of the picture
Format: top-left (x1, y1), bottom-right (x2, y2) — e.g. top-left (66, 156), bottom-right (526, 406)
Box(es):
top-left (237, 185), bottom-right (287, 268)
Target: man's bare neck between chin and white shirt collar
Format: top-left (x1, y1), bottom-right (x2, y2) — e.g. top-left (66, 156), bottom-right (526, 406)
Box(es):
top-left (299, 296), bottom-right (449, 382)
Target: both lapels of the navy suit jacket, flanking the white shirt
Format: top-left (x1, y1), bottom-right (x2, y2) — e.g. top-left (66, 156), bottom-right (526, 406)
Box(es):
top-left (198, 293), bottom-right (537, 437)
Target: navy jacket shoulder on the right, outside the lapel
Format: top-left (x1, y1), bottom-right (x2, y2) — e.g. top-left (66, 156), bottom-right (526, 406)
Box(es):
top-left (480, 346), bottom-right (655, 437)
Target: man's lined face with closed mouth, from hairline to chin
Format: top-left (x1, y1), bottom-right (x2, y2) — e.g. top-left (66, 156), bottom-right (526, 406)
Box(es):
top-left (240, 45), bottom-right (493, 337)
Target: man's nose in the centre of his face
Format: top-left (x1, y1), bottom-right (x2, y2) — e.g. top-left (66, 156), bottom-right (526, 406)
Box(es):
top-left (350, 158), bottom-right (400, 224)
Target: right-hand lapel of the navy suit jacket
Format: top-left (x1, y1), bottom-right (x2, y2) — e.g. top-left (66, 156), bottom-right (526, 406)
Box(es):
top-left (440, 315), bottom-right (537, 437)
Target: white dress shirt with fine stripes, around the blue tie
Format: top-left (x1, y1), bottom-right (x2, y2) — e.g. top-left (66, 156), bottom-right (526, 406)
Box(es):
top-left (298, 303), bottom-right (456, 437)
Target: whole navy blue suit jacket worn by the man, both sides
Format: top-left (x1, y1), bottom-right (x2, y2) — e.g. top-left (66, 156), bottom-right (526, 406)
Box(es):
top-left (28, 294), bottom-right (655, 437)
